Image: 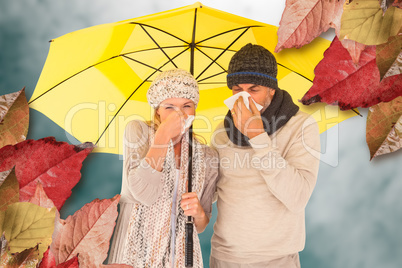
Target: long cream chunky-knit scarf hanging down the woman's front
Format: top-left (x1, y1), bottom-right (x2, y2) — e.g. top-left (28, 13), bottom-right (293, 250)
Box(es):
top-left (123, 127), bottom-right (206, 268)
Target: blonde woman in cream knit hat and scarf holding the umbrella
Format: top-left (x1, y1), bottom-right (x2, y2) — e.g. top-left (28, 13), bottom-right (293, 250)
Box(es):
top-left (109, 69), bottom-right (218, 268)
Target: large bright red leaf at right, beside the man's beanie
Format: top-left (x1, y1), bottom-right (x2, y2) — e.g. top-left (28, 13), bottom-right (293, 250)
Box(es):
top-left (301, 37), bottom-right (402, 110)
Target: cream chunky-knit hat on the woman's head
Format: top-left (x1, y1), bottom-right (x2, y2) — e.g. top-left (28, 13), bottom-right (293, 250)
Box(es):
top-left (147, 69), bottom-right (200, 109)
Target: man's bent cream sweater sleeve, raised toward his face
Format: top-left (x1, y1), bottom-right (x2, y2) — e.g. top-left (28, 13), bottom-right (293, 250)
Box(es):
top-left (250, 117), bottom-right (320, 213)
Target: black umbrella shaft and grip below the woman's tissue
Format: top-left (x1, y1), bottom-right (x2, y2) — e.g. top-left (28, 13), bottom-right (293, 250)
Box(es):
top-left (184, 125), bottom-right (194, 267)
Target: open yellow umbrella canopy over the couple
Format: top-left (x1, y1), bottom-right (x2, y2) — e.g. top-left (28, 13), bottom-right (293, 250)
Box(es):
top-left (29, 3), bottom-right (354, 154)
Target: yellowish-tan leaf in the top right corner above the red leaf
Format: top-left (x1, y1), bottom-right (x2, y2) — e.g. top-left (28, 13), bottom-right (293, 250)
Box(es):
top-left (339, 0), bottom-right (402, 45)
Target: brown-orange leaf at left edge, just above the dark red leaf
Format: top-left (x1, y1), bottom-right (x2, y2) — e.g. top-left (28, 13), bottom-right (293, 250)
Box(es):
top-left (0, 88), bottom-right (29, 148)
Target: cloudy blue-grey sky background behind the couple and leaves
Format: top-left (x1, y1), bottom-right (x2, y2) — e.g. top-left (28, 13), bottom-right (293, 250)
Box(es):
top-left (0, 0), bottom-right (402, 268)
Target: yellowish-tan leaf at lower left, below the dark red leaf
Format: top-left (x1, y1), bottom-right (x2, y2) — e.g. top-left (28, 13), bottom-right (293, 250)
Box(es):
top-left (0, 202), bottom-right (56, 257)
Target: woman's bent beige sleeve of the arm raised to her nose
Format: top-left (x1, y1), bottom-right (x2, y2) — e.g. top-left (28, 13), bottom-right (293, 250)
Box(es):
top-left (123, 121), bottom-right (163, 206)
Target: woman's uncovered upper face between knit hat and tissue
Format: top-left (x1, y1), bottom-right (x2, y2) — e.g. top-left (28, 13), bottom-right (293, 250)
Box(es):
top-left (156, 98), bottom-right (195, 122)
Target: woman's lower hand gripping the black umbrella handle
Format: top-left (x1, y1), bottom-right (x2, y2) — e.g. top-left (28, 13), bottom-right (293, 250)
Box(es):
top-left (180, 193), bottom-right (209, 233)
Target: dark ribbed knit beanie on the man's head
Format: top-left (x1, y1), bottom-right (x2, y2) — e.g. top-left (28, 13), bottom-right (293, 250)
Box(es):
top-left (227, 43), bottom-right (278, 89)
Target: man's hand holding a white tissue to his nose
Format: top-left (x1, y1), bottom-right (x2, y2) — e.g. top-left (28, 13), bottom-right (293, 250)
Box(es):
top-left (231, 97), bottom-right (265, 139)
